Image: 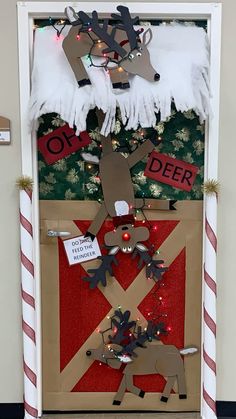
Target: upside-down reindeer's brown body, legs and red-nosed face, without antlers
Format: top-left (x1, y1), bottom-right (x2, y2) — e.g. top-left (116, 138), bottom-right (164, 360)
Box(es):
top-left (82, 111), bottom-right (176, 254)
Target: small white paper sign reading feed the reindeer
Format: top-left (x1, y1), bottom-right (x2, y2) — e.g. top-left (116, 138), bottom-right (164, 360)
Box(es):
top-left (63, 236), bottom-right (101, 266)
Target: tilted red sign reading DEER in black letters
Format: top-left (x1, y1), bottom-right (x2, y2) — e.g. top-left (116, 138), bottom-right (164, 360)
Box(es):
top-left (144, 151), bottom-right (198, 192)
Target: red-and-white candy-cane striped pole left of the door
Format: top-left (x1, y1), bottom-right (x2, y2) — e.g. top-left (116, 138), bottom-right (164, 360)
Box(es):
top-left (20, 190), bottom-right (38, 419)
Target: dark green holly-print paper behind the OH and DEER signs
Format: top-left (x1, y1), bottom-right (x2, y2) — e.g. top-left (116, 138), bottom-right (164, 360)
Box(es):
top-left (38, 108), bottom-right (204, 200)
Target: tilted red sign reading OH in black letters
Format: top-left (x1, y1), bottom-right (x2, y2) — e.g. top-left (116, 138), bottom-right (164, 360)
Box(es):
top-left (38, 124), bottom-right (91, 164)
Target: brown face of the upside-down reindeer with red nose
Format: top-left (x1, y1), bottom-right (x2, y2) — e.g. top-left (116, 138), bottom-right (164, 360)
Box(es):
top-left (105, 224), bottom-right (149, 253)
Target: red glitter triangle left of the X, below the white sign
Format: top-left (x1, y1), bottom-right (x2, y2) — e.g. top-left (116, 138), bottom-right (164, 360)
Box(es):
top-left (58, 240), bottom-right (111, 370)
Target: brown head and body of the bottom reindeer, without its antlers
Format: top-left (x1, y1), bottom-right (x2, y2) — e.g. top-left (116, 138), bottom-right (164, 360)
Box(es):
top-left (86, 322), bottom-right (198, 405)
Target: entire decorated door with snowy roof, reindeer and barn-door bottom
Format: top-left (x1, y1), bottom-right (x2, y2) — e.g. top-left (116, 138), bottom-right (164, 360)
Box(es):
top-left (31, 6), bottom-right (206, 411)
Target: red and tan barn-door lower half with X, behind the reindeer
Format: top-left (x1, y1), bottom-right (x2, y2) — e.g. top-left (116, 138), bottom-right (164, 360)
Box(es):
top-left (40, 201), bottom-right (202, 411)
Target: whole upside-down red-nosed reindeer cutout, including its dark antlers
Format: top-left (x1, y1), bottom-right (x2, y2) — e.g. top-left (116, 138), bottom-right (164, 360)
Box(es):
top-left (82, 112), bottom-right (176, 288)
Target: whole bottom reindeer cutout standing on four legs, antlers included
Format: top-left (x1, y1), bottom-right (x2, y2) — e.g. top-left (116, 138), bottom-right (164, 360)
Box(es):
top-left (86, 311), bottom-right (198, 405)
